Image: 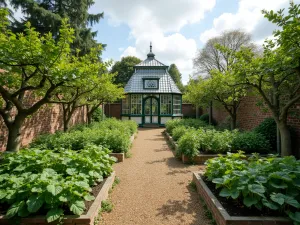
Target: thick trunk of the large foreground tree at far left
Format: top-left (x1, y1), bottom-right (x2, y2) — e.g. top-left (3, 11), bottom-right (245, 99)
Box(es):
top-left (6, 115), bottom-right (26, 152)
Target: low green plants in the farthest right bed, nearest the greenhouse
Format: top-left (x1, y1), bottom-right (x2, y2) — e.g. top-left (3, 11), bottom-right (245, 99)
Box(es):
top-left (166, 119), bottom-right (211, 135)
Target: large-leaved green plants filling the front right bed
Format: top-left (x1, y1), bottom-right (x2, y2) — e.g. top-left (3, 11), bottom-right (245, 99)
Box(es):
top-left (205, 152), bottom-right (300, 225)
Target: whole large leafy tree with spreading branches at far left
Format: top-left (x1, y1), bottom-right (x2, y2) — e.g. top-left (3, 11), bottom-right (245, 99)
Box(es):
top-left (0, 9), bottom-right (102, 151)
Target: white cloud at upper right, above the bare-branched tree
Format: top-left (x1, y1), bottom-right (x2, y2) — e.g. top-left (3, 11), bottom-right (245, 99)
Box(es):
top-left (200, 0), bottom-right (292, 44)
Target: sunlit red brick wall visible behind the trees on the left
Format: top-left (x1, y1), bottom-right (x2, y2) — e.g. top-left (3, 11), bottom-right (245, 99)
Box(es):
top-left (0, 104), bottom-right (86, 151)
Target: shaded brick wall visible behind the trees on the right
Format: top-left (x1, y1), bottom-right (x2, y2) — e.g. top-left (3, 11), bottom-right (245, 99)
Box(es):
top-left (213, 96), bottom-right (300, 157)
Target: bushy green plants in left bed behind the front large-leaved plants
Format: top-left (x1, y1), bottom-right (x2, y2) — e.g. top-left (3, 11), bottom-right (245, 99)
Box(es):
top-left (30, 119), bottom-right (137, 153)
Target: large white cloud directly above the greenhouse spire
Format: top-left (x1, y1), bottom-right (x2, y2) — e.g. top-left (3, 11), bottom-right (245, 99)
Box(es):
top-left (91, 0), bottom-right (216, 83)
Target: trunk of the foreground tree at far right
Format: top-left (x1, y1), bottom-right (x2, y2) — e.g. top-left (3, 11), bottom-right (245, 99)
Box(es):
top-left (278, 122), bottom-right (292, 156)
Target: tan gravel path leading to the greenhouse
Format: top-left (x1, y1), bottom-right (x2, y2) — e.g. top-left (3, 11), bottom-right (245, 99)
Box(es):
top-left (99, 128), bottom-right (209, 225)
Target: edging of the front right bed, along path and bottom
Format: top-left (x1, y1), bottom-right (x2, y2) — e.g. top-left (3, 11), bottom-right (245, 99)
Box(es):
top-left (193, 172), bottom-right (293, 225)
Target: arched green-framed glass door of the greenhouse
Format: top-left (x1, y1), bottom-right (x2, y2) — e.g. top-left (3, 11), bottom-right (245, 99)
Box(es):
top-left (144, 97), bottom-right (159, 124)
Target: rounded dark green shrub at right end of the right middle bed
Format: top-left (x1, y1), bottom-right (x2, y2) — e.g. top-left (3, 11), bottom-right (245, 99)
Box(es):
top-left (232, 131), bottom-right (271, 153)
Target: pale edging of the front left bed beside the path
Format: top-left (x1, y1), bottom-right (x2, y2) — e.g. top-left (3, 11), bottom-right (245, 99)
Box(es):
top-left (0, 172), bottom-right (116, 225)
